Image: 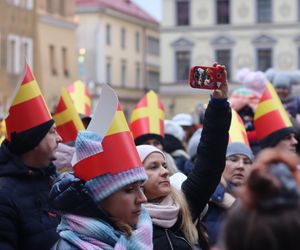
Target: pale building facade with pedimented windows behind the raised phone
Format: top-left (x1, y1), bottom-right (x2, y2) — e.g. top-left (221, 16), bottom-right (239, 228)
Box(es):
top-left (161, 0), bottom-right (300, 115)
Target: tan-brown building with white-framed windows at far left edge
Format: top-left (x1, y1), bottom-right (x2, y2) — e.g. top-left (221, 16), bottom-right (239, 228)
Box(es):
top-left (0, 0), bottom-right (35, 118)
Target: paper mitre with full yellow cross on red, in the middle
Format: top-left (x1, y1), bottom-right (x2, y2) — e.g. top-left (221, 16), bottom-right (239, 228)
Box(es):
top-left (130, 90), bottom-right (165, 144)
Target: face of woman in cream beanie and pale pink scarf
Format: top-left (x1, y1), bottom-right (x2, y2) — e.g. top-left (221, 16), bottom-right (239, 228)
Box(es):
top-left (143, 152), bottom-right (171, 201)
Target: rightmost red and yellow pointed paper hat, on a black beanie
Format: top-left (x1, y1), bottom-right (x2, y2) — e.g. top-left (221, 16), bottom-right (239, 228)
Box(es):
top-left (254, 83), bottom-right (292, 146)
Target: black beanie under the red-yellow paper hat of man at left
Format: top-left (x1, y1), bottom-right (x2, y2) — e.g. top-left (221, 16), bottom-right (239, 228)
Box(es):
top-left (7, 119), bottom-right (54, 155)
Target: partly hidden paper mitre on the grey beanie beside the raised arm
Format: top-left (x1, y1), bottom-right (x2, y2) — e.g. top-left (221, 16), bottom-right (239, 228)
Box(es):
top-left (229, 108), bottom-right (250, 147)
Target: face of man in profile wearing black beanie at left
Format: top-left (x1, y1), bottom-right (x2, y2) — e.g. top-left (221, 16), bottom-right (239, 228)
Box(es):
top-left (34, 125), bottom-right (62, 166)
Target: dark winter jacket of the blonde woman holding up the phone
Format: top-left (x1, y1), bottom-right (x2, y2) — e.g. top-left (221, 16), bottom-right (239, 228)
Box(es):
top-left (153, 99), bottom-right (231, 250)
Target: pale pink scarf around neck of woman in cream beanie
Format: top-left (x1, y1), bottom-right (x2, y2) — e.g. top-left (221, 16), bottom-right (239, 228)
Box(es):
top-left (144, 195), bottom-right (179, 228)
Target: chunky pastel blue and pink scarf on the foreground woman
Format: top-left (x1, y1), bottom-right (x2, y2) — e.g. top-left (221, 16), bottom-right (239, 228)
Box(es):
top-left (57, 208), bottom-right (153, 250)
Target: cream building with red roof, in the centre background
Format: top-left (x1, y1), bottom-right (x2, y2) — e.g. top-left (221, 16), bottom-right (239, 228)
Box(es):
top-left (76, 0), bottom-right (160, 114)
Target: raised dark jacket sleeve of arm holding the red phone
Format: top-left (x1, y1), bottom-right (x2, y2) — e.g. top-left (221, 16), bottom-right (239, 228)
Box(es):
top-left (182, 98), bottom-right (231, 220)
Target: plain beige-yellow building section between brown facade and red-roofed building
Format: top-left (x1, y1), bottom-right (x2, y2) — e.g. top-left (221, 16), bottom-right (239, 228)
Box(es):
top-left (34, 0), bottom-right (78, 111)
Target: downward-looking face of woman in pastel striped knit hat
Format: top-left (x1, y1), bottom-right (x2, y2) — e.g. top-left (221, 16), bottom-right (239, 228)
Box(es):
top-left (100, 181), bottom-right (147, 226)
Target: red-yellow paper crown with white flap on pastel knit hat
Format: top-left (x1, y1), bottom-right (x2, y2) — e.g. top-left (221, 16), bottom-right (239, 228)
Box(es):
top-left (73, 85), bottom-right (142, 181)
